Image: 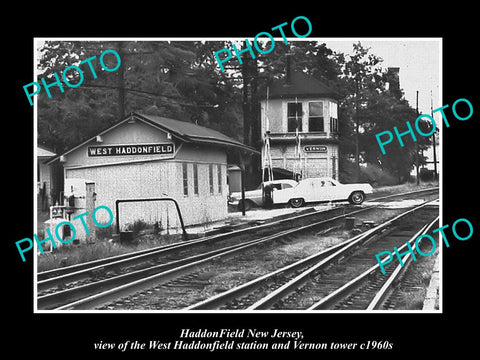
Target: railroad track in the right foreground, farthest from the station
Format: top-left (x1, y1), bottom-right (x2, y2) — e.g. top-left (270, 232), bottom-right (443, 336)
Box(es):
top-left (187, 202), bottom-right (437, 310)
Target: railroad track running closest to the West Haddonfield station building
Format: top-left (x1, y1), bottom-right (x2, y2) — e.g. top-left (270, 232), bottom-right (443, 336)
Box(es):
top-left (37, 189), bottom-right (438, 310)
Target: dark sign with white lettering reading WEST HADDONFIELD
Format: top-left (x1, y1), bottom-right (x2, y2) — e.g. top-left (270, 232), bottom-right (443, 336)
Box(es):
top-left (87, 143), bottom-right (175, 156)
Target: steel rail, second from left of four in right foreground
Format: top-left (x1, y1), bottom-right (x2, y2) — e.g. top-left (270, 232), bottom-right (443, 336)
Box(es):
top-left (248, 201), bottom-right (432, 310)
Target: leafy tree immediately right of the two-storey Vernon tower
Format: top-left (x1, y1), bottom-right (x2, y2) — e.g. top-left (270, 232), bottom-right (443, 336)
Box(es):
top-left (337, 42), bottom-right (430, 182)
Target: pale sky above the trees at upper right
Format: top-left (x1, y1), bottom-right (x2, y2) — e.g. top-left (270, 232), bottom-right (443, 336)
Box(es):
top-left (320, 38), bottom-right (444, 114)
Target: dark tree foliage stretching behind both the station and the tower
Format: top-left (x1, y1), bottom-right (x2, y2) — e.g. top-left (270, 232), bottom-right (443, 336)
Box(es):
top-left (38, 41), bottom-right (429, 181)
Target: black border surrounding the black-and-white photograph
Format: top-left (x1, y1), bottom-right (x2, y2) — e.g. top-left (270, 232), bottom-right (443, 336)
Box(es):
top-left (9, 7), bottom-right (480, 359)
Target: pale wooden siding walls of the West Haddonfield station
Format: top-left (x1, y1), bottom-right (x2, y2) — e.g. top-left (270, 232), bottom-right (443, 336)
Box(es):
top-left (64, 121), bottom-right (228, 229)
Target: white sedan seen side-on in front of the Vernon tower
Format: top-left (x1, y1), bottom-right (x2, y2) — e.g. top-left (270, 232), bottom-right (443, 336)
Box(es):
top-left (272, 177), bottom-right (373, 208)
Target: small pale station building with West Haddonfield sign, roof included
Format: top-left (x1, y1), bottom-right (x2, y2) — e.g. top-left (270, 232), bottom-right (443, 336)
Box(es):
top-left (49, 113), bottom-right (258, 231)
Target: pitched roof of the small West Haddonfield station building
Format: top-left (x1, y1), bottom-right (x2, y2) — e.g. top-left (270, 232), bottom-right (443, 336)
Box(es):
top-left (48, 112), bottom-right (260, 163)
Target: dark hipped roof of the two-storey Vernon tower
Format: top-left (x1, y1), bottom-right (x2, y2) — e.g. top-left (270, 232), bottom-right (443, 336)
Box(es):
top-left (263, 71), bottom-right (341, 99)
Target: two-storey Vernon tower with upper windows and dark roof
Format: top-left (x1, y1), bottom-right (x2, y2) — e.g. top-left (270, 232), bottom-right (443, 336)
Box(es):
top-left (260, 65), bottom-right (339, 179)
